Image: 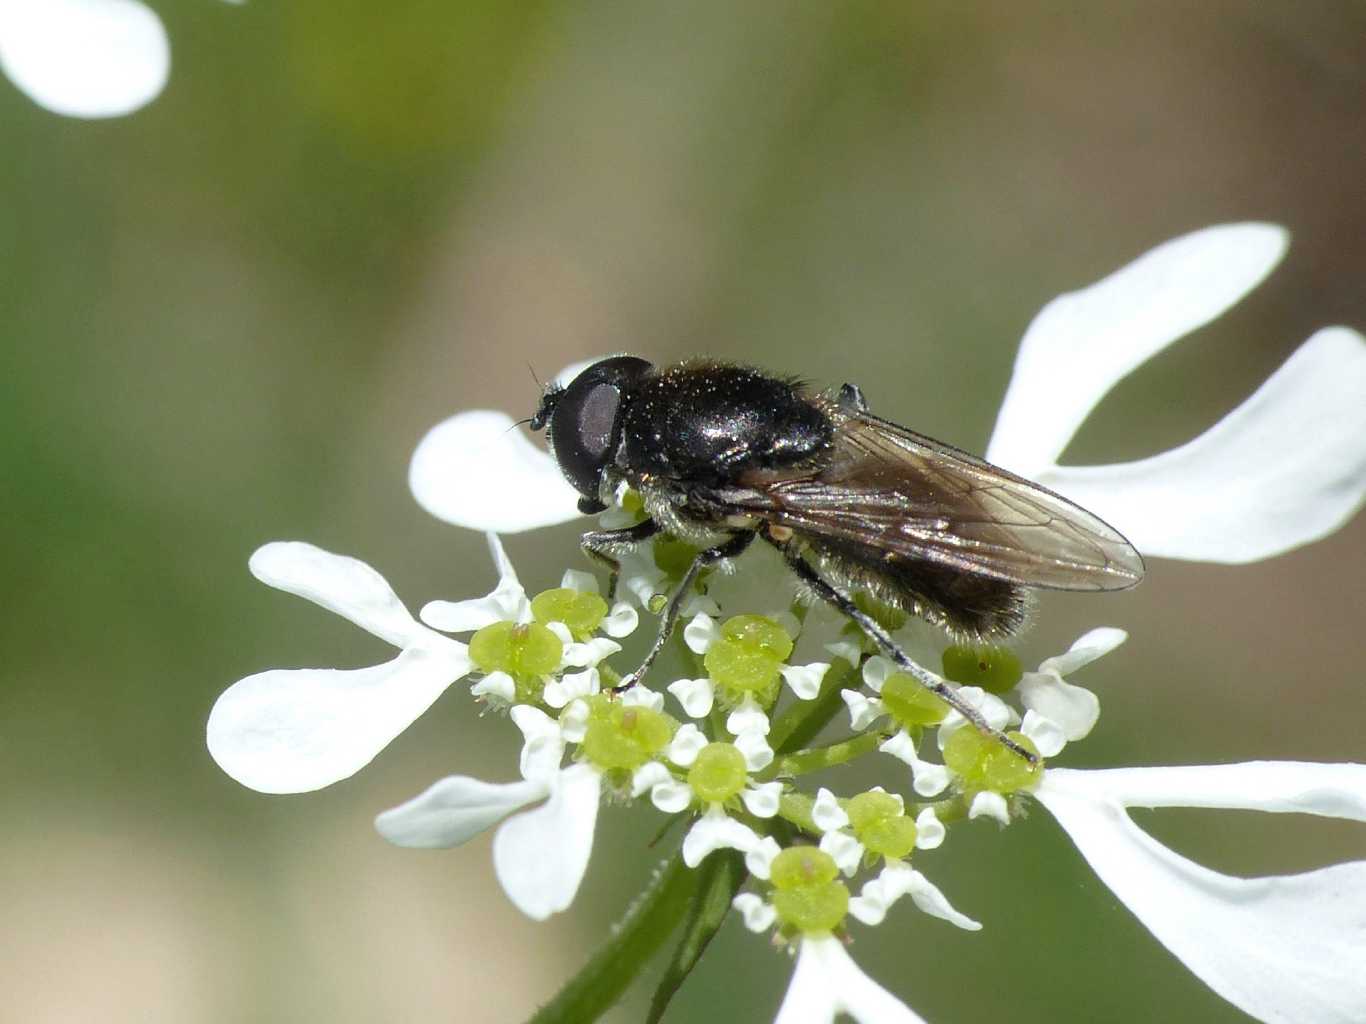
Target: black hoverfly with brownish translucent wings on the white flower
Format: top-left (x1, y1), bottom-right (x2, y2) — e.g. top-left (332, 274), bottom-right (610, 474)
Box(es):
top-left (530, 355), bottom-right (1143, 762)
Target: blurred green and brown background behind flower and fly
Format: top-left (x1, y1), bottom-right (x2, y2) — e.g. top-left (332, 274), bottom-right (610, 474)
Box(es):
top-left (0, 0), bottom-right (1366, 1024)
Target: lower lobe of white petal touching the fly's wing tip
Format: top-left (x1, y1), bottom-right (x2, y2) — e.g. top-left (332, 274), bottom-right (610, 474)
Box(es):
top-left (1034, 328), bottom-right (1366, 563)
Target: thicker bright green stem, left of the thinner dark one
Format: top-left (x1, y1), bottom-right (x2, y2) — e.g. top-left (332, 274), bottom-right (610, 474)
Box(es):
top-left (529, 853), bottom-right (698, 1024)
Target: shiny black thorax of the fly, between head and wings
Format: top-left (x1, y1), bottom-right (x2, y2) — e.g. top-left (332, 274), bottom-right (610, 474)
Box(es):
top-left (615, 362), bottom-right (835, 490)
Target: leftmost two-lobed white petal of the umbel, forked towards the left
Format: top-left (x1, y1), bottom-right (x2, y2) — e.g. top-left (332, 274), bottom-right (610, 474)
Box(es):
top-left (208, 542), bottom-right (470, 793)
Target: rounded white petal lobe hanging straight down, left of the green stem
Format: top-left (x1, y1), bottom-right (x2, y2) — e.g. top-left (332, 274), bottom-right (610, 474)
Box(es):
top-left (493, 765), bottom-right (602, 920)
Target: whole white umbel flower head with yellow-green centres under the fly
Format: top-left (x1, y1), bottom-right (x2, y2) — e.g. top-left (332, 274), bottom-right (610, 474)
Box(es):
top-left (209, 224), bottom-right (1366, 1024)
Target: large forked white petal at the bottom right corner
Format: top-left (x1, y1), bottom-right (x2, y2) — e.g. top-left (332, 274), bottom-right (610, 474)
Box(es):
top-left (1035, 762), bottom-right (1366, 1024)
